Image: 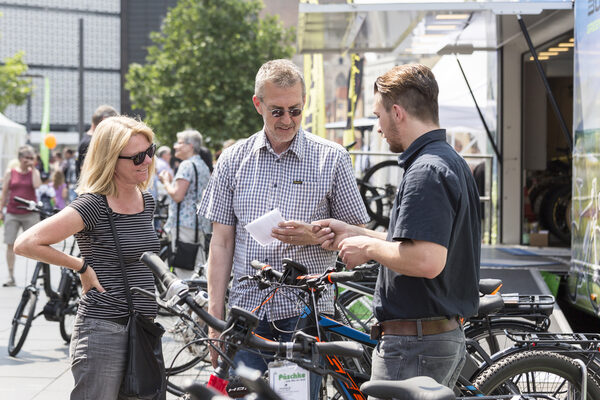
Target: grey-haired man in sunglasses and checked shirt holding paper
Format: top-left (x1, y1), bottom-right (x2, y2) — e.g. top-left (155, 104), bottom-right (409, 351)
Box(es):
top-left (200, 60), bottom-right (369, 392)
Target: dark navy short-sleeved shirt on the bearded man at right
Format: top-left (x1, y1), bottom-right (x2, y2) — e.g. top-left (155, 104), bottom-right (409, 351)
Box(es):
top-left (373, 129), bottom-right (481, 321)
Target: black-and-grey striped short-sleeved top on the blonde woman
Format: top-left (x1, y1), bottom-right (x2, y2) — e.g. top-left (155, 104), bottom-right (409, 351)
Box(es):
top-left (69, 192), bottom-right (160, 318)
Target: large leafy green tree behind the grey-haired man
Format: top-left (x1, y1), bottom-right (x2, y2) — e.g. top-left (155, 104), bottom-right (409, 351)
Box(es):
top-left (125, 0), bottom-right (295, 147)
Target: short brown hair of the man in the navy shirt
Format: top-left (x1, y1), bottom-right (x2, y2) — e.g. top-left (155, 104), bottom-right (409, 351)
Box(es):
top-left (374, 64), bottom-right (439, 124)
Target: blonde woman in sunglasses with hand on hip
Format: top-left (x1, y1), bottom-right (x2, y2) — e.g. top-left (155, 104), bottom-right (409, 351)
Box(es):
top-left (15, 116), bottom-right (164, 400)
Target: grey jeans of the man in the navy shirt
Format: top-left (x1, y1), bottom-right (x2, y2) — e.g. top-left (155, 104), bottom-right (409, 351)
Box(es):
top-left (371, 327), bottom-right (466, 389)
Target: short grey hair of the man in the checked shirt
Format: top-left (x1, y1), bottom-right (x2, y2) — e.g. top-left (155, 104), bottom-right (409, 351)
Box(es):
top-left (254, 59), bottom-right (306, 99)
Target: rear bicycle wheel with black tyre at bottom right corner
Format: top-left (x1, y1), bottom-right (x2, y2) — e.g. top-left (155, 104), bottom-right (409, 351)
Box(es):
top-left (474, 351), bottom-right (600, 400)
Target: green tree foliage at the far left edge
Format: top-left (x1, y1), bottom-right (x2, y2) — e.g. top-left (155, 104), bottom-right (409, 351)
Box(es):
top-left (0, 52), bottom-right (31, 112)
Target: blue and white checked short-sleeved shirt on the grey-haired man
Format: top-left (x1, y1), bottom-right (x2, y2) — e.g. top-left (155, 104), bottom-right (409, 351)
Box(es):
top-left (200, 129), bottom-right (369, 321)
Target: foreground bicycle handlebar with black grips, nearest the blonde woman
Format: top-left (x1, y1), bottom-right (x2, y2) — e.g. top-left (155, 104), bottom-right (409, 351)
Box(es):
top-left (140, 252), bottom-right (363, 357)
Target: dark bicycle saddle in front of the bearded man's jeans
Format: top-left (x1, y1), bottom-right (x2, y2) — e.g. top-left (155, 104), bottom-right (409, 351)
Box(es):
top-left (360, 376), bottom-right (456, 400)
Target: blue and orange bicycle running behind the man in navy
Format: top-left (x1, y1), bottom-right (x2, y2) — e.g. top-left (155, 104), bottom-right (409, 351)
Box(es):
top-left (243, 260), bottom-right (600, 399)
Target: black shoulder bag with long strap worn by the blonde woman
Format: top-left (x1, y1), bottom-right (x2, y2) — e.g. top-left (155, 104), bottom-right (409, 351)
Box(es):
top-left (102, 196), bottom-right (166, 400)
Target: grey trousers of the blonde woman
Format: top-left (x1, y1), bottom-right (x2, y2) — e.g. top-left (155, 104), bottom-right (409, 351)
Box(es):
top-left (70, 315), bottom-right (135, 400)
